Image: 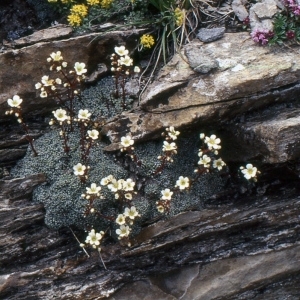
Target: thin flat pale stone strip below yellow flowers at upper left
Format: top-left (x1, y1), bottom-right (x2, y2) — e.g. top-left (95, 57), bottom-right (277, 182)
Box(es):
top-left (12, 24), bottom-right (73, 46)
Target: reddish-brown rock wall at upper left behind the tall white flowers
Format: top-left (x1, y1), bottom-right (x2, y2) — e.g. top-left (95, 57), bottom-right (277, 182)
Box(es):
top-left (0, 29), bottom-right (143, 122)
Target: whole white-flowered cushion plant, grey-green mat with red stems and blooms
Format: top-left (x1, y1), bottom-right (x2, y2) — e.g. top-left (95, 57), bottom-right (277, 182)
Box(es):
top-left (9, 47), bottom-right (258, 258)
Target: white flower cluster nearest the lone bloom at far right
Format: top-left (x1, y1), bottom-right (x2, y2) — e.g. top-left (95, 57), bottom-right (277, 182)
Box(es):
top-left (195, 133), bottom-right (226, 172)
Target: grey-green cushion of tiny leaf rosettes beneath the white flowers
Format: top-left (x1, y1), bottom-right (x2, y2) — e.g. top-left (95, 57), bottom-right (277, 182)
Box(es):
top-left (12, 79), bottom-right (223, 239)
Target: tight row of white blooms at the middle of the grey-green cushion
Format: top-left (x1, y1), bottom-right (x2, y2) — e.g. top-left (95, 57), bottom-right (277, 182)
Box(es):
top-left (100, 175), bottom-right (135, 200)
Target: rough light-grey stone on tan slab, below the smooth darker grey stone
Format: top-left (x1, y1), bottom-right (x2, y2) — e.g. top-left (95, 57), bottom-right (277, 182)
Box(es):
top-left (185, 47), bottom-right (219, 74)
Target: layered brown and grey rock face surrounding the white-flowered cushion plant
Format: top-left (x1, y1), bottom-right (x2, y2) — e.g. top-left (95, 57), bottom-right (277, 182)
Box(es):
top-left (0, 26), bottom-right (300, 300)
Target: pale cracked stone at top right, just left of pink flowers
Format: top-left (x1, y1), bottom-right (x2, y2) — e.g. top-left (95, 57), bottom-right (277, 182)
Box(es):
top-left (249, 0), bottom-right (278, 31)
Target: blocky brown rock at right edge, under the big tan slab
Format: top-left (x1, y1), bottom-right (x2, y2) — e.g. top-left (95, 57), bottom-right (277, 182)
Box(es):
top-left (224, 106), bottom-right (300, 164)
